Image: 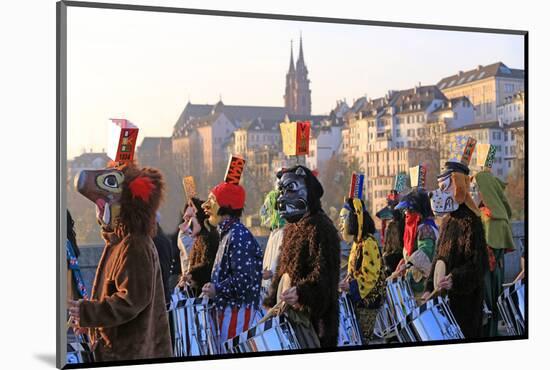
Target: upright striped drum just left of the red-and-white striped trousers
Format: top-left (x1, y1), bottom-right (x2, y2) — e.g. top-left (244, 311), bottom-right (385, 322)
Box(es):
top-left (168, 293), bottom-right (220, 357)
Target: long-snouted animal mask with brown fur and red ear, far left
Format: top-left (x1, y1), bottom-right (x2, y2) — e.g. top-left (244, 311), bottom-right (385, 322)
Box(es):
top-left (76, 164), bottom-right (164, 235)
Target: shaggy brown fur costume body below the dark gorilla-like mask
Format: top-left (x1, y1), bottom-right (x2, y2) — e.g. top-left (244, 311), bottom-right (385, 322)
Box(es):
top-left (264, 211), bottom-right (340, 348)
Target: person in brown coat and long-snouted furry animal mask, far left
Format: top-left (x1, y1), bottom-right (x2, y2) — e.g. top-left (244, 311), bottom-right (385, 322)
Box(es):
top-left (69, 163), bottom-right (172, 361)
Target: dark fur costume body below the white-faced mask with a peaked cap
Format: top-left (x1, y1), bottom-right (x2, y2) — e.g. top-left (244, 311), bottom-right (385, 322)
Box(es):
top-left (426, 203), bottom-right (488, 339)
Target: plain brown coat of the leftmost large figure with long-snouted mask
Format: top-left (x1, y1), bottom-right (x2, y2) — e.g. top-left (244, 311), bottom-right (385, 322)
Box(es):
top-left (80, 228), bottom-right (172, 361)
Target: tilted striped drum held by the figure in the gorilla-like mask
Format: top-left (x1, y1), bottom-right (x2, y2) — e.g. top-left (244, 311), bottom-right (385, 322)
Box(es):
top-left (223, 315), bottom-right (301, 353)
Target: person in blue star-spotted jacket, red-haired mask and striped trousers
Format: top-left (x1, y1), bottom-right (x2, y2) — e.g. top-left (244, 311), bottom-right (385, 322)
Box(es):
top-left (202, 182), bottom-right (263, 343)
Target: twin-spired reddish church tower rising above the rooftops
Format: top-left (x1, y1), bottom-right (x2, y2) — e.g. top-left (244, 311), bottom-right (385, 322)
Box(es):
top-left (284, 35), bottom-right (311, 116)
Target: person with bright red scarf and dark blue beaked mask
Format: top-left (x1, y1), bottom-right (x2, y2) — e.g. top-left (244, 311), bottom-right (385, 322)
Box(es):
top-left (392, 189), bottom-right (439, 297)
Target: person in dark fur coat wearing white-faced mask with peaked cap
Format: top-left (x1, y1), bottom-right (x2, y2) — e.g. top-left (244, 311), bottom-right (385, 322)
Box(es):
top-left (423, 138), bottom-right (488, 339)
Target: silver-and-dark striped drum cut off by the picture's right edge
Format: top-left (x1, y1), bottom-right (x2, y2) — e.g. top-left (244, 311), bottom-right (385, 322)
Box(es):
top-left (497, 281), bottom-right (525, 335)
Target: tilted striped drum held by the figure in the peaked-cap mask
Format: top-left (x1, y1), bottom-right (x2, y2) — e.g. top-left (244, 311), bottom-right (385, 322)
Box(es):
top-left (396, 297), bottom-right (464, 343)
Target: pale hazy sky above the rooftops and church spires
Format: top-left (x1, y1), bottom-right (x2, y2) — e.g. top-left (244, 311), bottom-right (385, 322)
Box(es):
top-left (67, 7), bottom-right (524, 158)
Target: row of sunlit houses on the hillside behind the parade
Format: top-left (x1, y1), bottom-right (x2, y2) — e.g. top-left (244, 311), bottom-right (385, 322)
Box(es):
top-left (69, 62), bottom-right (525, 218)
